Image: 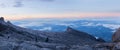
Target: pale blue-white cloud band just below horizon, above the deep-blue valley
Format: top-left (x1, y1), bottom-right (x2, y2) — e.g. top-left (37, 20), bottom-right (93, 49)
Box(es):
top-left (11, 19), bottom-right (120, 32)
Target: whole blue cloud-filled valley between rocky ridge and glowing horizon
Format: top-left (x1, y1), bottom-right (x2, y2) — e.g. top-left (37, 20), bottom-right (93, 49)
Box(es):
top-left (12, 19), bottom-right (120, 40)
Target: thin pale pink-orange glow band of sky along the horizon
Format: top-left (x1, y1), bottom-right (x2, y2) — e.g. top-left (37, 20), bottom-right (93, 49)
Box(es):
top-left (3, 13), bottom-right (120, 20)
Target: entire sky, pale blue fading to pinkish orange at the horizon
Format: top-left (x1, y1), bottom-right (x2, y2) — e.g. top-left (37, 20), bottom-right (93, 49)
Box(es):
top-left (0, 0), bottom-right (120, 20)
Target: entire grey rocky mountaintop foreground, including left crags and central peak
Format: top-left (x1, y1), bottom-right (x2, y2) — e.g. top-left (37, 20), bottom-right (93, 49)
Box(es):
top-left (0, 17), bottom-right (120, 50)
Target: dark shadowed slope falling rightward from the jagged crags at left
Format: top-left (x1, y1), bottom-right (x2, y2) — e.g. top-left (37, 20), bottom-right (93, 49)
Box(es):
top-left (0, 18), bottom-right (43, 41)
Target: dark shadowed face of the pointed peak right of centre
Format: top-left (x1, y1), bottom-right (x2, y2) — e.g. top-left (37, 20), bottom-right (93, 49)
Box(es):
top-left (64, 27), bottom-right (101, 45)
